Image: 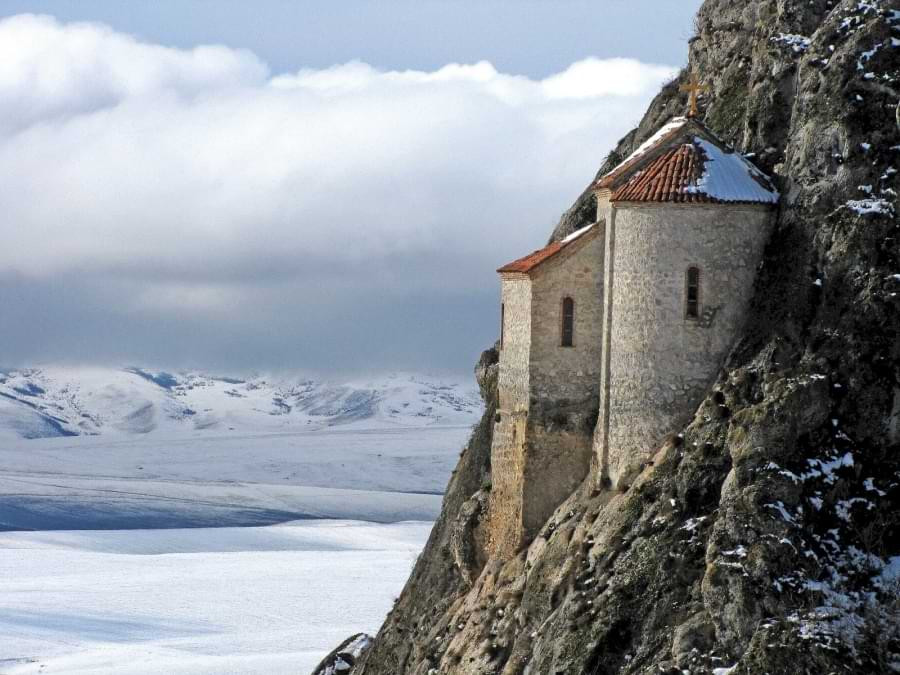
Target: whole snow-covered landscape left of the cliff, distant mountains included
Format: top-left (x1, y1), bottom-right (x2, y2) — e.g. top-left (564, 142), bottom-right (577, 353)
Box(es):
top-left (0, 370), bottom-right (480, 675)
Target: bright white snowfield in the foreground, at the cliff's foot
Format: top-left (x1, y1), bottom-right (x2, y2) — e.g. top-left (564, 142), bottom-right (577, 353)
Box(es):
top-left (0, 521), bottom-right (431, 675)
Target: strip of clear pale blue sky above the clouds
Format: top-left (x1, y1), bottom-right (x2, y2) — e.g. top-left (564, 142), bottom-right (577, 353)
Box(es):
top-left (0, 0), bottom-right (701, 77)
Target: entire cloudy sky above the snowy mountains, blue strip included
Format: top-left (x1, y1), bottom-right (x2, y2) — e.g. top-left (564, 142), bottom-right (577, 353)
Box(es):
top-left (0, 0), bottom-right (699, 373)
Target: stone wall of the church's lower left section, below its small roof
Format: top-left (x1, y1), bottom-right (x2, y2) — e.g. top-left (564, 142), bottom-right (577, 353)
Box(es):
top-left (488, 224), bottom-right (604, 558)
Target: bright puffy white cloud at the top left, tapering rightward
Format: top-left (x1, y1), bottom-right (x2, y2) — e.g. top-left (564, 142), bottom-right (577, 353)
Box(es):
top-left (0, 14), bottom-right (268, 133)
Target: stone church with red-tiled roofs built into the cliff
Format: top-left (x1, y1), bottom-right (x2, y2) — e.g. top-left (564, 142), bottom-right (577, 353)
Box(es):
top-left (489, 116), bottom-right (779, 557)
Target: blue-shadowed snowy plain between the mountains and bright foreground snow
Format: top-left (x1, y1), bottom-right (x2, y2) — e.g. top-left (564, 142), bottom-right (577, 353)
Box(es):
top-left (0, 426), bottom-right (469, 530)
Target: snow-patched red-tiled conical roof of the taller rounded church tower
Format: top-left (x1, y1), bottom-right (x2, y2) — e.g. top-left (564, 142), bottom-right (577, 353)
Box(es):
top-left (595, 117), bottom-right (779, 204)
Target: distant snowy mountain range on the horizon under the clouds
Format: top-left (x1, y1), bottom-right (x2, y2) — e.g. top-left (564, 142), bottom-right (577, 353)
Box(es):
top-left (0, 366), bottom-right (482, 439)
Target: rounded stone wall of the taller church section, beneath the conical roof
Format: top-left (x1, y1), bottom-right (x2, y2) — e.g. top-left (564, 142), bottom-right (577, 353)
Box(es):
top-left (594, 204), bottom-right (772, 486)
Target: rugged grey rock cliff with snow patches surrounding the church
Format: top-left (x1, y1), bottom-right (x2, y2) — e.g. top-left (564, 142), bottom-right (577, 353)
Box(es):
top-left (353, 0), bottom-right (900, 675)
